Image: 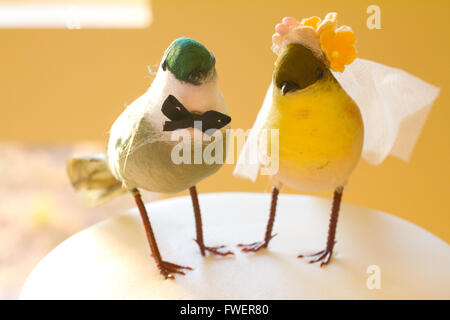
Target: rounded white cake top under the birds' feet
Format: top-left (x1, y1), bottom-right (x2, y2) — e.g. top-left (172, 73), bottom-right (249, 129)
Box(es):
top-left (21, 193), bottom-right (450, 299)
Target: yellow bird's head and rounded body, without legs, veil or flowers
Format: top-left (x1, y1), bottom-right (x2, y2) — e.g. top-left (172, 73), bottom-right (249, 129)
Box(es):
top-left (263, 43), bottom-right (363, 191)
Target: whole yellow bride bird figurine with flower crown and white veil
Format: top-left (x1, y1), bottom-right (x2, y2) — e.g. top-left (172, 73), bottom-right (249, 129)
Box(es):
top-left (234, 13), bottom-right (439, 266)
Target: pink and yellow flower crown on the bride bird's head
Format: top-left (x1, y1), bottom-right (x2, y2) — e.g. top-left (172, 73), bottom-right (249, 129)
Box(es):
top-left (272, 12), bottom-right (357, 72)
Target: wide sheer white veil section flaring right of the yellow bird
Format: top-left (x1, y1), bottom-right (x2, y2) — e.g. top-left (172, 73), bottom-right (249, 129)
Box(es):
top-left (333, 59), bottom-right (440, 165)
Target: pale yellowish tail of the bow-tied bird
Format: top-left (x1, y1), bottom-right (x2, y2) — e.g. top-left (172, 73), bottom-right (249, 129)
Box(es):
top-left (67, 154), bottom-right (127, 206)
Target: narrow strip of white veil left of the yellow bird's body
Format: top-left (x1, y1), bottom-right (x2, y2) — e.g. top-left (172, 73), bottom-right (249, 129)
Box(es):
top-left (233, 83), bottom-right (273, 182)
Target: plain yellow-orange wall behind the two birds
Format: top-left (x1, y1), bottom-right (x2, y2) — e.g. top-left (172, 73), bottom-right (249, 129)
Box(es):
top-left (0, 0), bottom-right (450, 242)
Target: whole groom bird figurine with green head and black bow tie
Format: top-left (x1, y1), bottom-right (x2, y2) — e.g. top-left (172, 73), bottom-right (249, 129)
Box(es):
top-left (68, 38), bottom-right (236, 278)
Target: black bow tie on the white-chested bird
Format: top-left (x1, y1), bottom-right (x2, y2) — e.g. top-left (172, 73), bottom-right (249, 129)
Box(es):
top-left (161, 95), bottom-right (231, 132)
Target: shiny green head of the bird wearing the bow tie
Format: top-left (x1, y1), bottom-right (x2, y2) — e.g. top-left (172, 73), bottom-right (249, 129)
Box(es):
top-left (162, 37), bottom-right (216, 85)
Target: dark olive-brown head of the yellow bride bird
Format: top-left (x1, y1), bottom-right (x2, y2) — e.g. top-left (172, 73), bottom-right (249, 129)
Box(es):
top-left (273, 43), bottom-right (331, 95)
